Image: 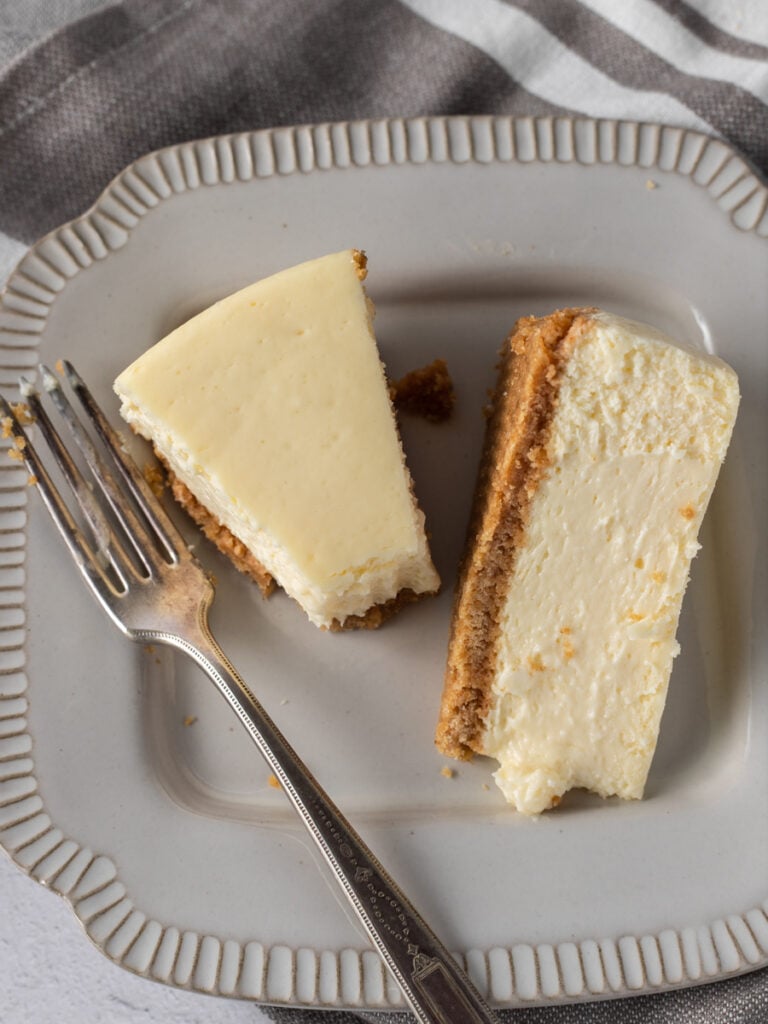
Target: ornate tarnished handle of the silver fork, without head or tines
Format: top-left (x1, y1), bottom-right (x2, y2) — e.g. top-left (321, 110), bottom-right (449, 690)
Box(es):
top-left (166, 623), bottom-right (495, 1024)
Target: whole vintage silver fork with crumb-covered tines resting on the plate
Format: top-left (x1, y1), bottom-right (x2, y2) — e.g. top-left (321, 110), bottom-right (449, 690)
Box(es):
top-left (0, 362), bottom-right (501, 1024)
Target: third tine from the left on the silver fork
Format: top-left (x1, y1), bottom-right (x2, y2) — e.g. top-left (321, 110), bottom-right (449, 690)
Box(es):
top-left (40, 365), bottom-right (178, 575)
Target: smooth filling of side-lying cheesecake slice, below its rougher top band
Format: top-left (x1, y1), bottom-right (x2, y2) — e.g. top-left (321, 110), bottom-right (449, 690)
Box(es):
top-left (481, 455), bottom-right (712, 813)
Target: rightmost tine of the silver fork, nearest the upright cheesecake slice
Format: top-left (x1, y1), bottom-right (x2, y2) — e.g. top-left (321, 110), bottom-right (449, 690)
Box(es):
top-left (62, 359), bottom-right (189, 562)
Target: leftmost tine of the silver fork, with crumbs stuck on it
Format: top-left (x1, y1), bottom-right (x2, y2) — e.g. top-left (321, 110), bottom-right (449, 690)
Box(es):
top-left (0, 395), bottom-right (125, 597)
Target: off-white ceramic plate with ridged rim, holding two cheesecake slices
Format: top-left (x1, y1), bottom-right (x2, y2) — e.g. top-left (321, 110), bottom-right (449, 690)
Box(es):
top-left (0, 118), bottom-right (768, 1009)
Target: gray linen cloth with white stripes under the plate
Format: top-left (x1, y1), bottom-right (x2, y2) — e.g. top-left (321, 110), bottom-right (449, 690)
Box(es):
top-left (0, 0), bottom-right (768, 1024)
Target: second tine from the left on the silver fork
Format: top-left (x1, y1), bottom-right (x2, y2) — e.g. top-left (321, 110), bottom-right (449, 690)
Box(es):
top-left (19, 377), bottom-right (137, 586)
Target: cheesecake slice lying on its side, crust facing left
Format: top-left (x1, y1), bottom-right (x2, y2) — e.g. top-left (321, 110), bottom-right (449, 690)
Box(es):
top-left (436, 308), bottom-right (738, 814)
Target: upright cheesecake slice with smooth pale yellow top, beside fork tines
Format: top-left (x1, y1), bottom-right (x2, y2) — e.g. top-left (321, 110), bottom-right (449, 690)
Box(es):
top-left (115, 250), bottom-right (439, 629)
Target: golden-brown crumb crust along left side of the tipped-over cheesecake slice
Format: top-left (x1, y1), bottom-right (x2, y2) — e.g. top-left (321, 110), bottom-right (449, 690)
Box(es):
top-left (435, 308), bottom-right (595, 760)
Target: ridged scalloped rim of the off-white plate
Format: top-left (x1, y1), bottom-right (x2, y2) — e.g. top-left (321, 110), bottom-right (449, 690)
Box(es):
top-left (0, 115), bottom-right (768, 1010)
